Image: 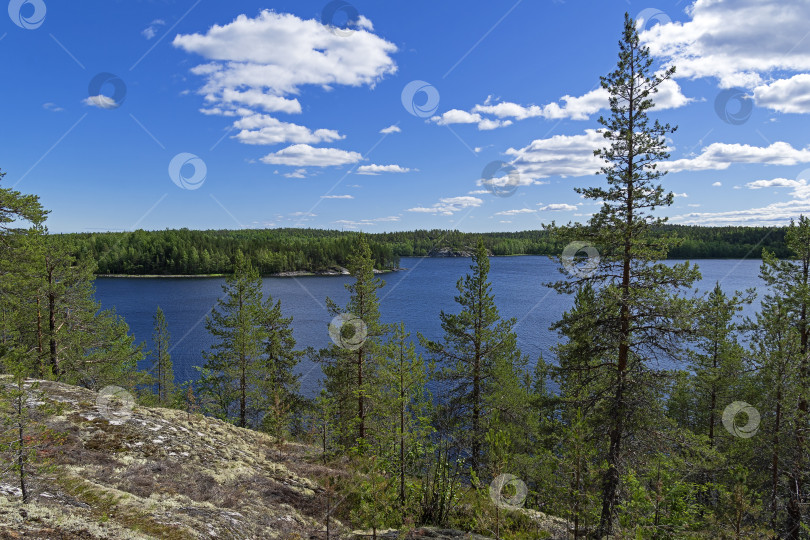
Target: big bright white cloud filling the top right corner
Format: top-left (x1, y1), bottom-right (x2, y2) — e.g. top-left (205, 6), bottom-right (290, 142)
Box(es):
top-left (641, 0), bottom-right (810, 112)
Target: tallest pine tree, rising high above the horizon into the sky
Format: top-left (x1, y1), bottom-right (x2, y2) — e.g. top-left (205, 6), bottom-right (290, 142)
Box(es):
top-left (552, 14), bottom-right (699, 537)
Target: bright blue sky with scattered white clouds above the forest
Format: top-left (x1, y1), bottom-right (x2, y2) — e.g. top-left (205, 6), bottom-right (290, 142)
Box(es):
top-left (0, 0), bottom-right (810, 232)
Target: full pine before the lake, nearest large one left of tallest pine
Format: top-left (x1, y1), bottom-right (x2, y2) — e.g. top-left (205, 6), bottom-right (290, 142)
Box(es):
top-left (421, 238), bottom-right (525, 475)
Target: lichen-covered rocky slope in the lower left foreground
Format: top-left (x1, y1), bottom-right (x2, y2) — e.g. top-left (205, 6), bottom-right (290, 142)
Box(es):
top-left (0, 381), bottom-right (340, 539)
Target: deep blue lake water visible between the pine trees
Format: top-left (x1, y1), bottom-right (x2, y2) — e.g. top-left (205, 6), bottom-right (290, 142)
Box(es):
top-left (96, 256), bottom-right (764, 395)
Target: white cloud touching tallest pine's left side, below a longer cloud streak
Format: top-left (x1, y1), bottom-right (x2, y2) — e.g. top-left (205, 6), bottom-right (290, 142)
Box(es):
top-left (506, 129), bottom-right (606, 180)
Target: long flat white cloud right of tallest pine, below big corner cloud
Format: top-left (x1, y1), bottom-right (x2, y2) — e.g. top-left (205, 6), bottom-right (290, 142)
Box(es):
top-left (660, 142), bottom-right (810, 172)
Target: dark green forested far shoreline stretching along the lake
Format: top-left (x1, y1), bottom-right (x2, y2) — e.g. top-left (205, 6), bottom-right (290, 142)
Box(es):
top-left (53, 224), bottom-right (789, 276)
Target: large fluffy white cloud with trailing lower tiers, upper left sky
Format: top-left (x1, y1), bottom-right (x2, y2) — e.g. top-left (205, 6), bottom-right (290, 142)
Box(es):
top-left (173, 10), bottom-right (397, 167)
